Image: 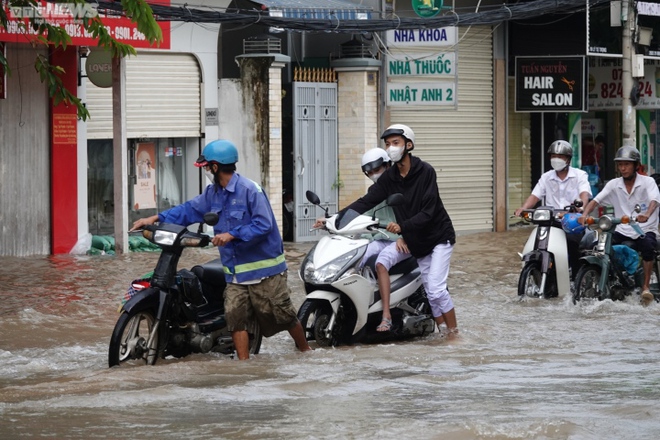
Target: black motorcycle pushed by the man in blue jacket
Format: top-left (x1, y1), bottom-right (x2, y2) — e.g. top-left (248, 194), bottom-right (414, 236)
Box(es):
top-left (108, 213), bottom-right (262, 367)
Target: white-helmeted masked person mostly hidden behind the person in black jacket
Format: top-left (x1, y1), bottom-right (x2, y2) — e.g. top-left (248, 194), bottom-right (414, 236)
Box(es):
top-left (360, 147), bottom-right (410, 332)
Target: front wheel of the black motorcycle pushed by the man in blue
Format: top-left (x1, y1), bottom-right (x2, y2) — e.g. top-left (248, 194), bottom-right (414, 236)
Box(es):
top-left (108, 310), bottom-right (159, 367)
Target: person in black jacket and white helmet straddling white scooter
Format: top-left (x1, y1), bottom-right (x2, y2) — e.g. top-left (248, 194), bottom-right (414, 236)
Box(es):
top-left (344, 124), bottom-right (458, 334)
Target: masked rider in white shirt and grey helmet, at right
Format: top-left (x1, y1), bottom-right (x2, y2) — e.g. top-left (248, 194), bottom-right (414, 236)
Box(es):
top-left (515, 140), bottom-right (591, 278)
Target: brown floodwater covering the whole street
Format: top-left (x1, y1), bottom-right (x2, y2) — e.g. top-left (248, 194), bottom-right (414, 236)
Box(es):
top-left (0, 228), bottom-right (660, 439)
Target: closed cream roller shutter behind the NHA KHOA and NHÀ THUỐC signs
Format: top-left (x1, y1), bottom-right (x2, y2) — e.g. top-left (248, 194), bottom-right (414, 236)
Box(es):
top-left (390, 26), bottom-right (494, 232)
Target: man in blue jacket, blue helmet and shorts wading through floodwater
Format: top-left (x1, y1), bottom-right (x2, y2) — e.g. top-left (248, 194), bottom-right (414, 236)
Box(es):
top-left (131, 139), bottom-right (311, 360)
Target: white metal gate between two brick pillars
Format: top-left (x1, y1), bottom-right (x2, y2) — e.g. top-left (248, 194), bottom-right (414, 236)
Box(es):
top-left (293, 82), bottom-right (339, 241)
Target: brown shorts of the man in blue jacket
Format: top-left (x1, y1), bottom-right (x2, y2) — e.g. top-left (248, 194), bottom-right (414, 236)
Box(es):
top-left (225, 272), bottom-right (298, 337)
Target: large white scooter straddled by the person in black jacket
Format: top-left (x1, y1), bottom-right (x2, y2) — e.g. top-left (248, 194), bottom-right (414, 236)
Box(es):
top-left (298, 191), bottom-right (435, 346)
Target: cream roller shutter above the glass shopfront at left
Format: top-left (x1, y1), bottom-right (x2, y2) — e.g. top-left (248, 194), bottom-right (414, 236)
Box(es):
top-left (86, 52), bottom-right (202, 139)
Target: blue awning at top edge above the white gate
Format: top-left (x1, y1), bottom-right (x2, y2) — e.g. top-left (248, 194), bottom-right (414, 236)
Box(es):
top-left (253, 0), bottom-right (372, 20)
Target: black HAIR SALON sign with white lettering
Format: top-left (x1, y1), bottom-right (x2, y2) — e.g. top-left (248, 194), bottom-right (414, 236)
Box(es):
top-left (516, 56), bottom-right (586, 112)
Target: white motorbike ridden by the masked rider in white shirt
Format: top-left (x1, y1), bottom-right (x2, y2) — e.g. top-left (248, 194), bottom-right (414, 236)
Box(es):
top-left (518, 202), bottom-right (581, 299)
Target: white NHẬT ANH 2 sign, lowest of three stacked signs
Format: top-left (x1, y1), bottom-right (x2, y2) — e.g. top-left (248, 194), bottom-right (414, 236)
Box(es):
top-left (387, 81), bottom-right (457, 107)
